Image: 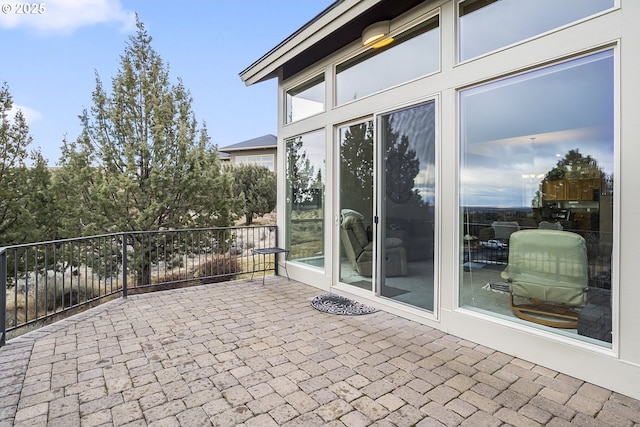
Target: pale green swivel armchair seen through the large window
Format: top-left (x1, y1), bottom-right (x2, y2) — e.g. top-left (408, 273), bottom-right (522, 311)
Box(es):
top-left (502, 229), bottom-right (589, 328)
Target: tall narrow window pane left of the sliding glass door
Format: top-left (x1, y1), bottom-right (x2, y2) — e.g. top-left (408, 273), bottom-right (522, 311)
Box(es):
top-left (286, 131), bottom-right (325, 268)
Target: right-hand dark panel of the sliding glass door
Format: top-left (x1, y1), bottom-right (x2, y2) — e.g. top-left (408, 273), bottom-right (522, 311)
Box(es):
top-left (376, 101), bottom-right (436, 311)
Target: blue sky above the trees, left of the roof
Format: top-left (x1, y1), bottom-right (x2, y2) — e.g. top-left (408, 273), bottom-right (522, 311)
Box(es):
top-left (0, 0), bottom-right (333, 166)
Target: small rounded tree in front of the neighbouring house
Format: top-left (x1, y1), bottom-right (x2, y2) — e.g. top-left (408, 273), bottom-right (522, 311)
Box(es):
top-left (232, 165), bottom-right (277, 225)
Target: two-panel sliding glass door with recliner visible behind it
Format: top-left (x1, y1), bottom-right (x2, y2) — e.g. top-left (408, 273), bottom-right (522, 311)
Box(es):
top-left (338, 102), bottom-right (436, 311)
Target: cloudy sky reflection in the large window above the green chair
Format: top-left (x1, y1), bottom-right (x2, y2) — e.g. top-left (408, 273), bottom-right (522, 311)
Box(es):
top-left (460, 50), bottom-right (614, 207)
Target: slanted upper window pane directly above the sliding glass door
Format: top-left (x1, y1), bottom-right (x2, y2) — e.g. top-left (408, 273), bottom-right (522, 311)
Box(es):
top-left (336, 17), bottom-right (440, 105)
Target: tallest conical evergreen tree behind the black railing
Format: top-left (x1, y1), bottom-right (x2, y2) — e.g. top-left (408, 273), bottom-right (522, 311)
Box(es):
top-left (56, 16), bottom-right (237, 285)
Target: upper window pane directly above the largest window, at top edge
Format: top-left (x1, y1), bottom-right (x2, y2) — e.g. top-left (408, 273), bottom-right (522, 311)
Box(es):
top-left (459, 0), bottom-right (614, 61)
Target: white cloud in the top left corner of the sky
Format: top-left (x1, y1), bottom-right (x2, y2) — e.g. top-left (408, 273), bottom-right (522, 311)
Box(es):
top-left (0, 0), bottom-right (135, 34)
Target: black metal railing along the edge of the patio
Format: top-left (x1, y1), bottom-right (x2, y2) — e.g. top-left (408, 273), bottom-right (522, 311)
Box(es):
top-left (0, 226), bottom-right (277, 346)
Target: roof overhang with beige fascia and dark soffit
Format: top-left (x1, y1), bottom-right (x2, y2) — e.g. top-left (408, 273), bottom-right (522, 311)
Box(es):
top-left (240, 0), bottom-right (425, 86)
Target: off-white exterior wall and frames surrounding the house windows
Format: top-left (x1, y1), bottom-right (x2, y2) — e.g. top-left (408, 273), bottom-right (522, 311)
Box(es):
top-left (277, 0), bottom-right (640, 399)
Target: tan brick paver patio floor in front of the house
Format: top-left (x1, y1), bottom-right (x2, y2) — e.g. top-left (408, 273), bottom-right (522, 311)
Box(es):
top-left (0, 278), bottom-right (640, 427)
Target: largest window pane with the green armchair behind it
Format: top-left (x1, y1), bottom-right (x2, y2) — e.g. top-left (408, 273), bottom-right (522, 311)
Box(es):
top-left (460, 51), bottom-right (614, 345)
